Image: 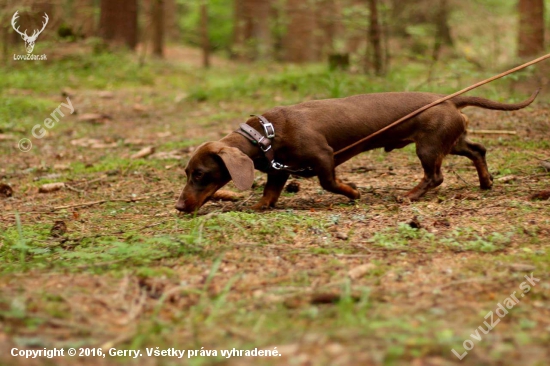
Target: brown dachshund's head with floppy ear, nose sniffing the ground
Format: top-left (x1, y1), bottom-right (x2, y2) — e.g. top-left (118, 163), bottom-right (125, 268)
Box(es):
top-left (176, 141), bottom-right (254, 213)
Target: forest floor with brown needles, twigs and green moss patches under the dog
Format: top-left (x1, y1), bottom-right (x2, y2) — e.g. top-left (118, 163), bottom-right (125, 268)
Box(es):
top-left (0, 43), bottom-right (550, 365)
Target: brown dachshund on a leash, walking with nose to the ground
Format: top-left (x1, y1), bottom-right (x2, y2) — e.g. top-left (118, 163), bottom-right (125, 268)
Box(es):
top-left (176, 91), bottom-right (538, 212)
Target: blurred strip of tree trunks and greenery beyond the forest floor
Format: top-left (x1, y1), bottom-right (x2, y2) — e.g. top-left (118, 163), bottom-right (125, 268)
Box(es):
top-left (0, 0), bottom-right (550, 75)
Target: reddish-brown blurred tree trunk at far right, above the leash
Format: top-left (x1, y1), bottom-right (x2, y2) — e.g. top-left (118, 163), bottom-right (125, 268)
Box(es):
top-left (518, 0), bottom-right (544, 57)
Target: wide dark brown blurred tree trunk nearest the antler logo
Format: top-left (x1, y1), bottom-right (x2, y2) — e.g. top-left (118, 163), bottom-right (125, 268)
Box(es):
top-left (99, 0), bottom-right (138, 50)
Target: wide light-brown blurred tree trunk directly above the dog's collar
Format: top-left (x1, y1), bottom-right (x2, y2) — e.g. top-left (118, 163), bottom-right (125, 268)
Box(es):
top-left (233, 0), bottom-right (272, 60)
